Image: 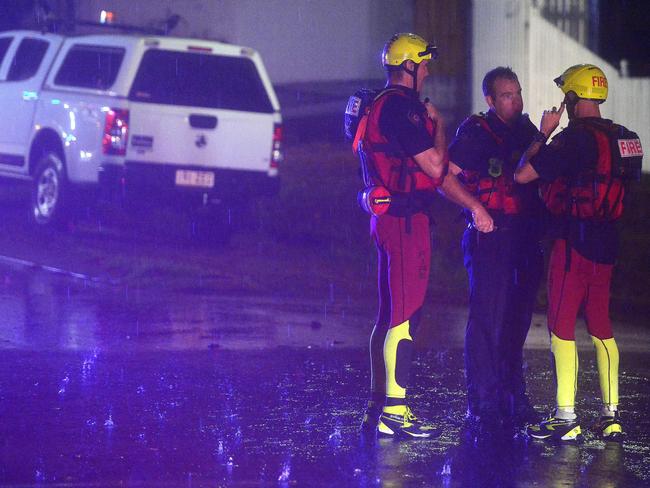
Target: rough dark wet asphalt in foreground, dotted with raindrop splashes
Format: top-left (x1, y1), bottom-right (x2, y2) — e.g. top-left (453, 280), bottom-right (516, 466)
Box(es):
top-left (0, 348), bottom-right (648, 486)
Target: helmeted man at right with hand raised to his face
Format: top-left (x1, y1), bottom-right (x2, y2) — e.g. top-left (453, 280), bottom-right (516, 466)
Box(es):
top-left (515, 64), bottom-right (643, 441)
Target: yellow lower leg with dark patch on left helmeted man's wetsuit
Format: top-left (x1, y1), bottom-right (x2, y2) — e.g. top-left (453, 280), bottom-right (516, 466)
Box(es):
top-left (384, 320), bottom-right (413, 414)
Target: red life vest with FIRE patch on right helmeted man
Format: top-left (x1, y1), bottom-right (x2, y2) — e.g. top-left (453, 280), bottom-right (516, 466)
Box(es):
top-left (540, 119), bottom-right (643, 221)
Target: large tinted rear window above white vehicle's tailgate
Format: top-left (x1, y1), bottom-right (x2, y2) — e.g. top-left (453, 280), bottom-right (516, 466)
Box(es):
top-left (129, 49), bottom-right (273, 113)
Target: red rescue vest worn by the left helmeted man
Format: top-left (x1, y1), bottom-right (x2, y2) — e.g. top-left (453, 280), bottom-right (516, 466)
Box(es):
top-left (352, 88), bottom-right (444, 194)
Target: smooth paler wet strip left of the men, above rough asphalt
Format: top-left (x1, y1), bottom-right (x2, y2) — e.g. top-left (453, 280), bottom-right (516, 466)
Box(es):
top-left (0, 266), bottom-right (366, 350)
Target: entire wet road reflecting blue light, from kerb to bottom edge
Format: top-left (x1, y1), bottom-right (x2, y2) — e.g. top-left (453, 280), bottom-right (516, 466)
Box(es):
top-left (0, 261), bottom-right (650, 487)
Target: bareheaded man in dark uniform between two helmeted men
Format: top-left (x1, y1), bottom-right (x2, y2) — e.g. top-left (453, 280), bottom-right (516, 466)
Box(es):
top-left (449, 67), bottom-right (544, 432)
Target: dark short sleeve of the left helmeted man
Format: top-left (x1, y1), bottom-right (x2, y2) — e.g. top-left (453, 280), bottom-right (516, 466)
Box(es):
top-left (379, 96), bottom-right (434, 156)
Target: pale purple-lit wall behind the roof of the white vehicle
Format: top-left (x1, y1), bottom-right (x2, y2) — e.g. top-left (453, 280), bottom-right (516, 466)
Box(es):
top-left (76, 0), bottom-right (414, 84)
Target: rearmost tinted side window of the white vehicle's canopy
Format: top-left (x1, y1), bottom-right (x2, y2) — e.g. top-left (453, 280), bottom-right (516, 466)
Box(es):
top-left (54, 44), bottom-right (124, 90)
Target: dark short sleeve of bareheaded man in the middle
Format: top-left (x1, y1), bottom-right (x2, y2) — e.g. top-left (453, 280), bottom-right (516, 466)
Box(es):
top-left (449, 120), bottom-right (493, 171)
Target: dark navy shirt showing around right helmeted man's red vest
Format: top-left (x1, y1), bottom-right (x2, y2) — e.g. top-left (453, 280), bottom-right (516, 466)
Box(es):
top-left (530, 118), bottom-right (618, 264)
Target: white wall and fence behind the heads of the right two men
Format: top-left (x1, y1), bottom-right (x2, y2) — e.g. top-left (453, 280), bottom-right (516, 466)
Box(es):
top-left (472, 0), bottom-right (650, 172)
